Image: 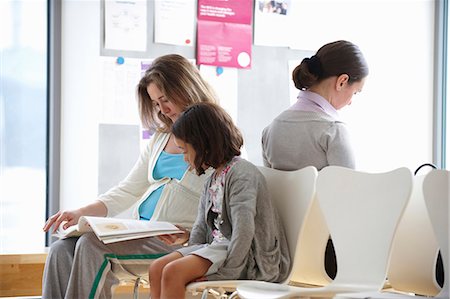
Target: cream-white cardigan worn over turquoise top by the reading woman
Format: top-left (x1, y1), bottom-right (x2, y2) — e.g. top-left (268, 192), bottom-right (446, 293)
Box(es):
top-left (98, 132), bottom-right (210, 228)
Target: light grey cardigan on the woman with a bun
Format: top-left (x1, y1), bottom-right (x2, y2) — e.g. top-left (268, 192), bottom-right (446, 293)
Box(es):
top-left (262, 110), bottom-right (355, 170)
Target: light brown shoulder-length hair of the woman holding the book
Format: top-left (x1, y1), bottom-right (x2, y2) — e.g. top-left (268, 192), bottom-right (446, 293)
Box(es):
top-left (137, 54), bottom-right (218, 132)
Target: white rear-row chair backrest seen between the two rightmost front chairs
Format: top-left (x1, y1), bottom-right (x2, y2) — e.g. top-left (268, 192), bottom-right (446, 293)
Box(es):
top-left (387, 175), bottom-right (441, 296)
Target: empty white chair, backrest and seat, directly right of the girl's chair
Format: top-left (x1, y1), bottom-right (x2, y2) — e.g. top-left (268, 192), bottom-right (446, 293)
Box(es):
top-left (237, 166), bottom-right (412, 299)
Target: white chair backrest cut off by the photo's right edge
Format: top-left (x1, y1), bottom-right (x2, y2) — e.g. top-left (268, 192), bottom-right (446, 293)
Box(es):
top-left (423, 170), bottom-right (450, 298)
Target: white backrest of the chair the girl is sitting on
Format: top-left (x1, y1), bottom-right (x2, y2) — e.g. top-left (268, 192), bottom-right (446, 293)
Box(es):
top-left (259, 166), bottom-right (317, 281)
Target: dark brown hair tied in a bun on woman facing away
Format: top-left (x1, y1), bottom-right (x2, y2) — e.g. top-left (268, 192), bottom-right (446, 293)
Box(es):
top-left (292, 40), bottom-right (369, 90)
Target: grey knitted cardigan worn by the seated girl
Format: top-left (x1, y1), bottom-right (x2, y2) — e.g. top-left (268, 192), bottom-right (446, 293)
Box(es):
top-left (189, 159), bottom-right (290, 282)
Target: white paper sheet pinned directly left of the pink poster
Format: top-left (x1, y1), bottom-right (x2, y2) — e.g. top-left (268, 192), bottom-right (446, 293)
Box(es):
top-left (155, 0), bottom-right (196, 46)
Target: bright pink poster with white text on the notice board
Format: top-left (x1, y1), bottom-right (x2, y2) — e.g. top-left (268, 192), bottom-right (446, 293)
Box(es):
top-left (197, 0), bottom-right (253, 68)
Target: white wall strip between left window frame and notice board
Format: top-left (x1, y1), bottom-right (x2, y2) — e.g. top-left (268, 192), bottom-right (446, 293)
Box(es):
top-left (60, 1), bottom-right (100, 209)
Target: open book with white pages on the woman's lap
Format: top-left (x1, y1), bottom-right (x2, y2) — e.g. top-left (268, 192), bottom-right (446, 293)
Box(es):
top-left (54, 216), bottom-right (182, 244)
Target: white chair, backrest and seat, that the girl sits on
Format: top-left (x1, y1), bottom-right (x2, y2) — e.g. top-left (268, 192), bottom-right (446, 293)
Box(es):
top-left (186, 166), bottom-right (318, 298)
